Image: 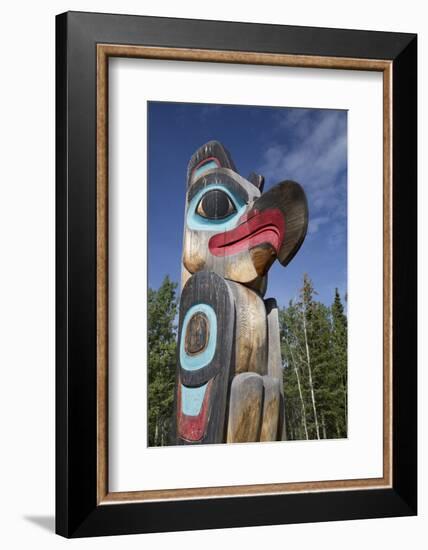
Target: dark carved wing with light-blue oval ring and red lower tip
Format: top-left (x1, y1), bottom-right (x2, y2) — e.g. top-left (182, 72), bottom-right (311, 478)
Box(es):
top-left (176, 271), bottom-right (235, 443)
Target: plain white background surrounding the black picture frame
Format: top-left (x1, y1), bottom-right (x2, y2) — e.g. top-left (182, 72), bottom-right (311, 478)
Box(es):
top-left (0, 0), bottom-right (422, 550)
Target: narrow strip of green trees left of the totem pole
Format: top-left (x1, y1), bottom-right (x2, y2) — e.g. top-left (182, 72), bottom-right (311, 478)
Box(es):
top-left (148, 276), bottom-right (177, 446)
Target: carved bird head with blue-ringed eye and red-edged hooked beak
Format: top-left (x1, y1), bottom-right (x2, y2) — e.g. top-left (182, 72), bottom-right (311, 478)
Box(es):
top-left (183, 141), bottom-right (308, 290)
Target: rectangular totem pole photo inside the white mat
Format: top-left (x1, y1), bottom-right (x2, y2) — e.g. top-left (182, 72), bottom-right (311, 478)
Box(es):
top-left (147, 101), bottom-right (352, 447)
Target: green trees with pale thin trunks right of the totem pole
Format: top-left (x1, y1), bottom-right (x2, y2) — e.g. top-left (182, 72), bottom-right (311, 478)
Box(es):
top-left (280, 274), bottom-right (347, 439)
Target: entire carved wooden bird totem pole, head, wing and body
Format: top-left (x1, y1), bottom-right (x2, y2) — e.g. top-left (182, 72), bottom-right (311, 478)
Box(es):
top-left (176, 141), bottom-right (308, 444)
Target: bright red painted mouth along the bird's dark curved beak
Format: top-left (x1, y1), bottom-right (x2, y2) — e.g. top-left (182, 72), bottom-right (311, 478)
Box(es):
top-left (208, 208), bottom-right (285, 256)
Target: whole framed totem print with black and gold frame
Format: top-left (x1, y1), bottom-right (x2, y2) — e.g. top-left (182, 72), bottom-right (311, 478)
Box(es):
top-left (56, 12), bottom-right (417, 537)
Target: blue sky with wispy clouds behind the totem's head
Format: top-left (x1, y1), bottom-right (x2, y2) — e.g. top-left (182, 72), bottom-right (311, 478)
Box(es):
top-left (148, 102), bottom-right (347, 306)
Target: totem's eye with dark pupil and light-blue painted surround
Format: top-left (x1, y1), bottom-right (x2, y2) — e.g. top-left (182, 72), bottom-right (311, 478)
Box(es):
top-left (186, 183), bottom-right (247, 231)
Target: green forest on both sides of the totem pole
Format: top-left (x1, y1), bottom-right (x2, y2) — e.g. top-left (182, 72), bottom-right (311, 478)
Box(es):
top-left (148, 274), bottom-right (347, 446)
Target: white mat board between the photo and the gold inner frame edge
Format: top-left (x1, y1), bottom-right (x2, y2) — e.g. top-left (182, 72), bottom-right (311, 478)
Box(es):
top-left (109, 59), bottom-right (383, 491)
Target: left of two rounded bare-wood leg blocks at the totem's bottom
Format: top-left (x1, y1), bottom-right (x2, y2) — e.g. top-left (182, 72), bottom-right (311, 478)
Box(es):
top-left (227, 372), bottom-right (263, 443)
